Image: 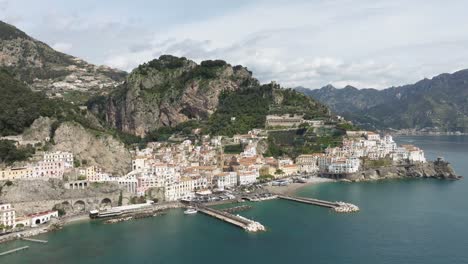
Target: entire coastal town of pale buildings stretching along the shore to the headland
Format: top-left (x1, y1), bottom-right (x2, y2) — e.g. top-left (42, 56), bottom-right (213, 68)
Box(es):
top-left (0, 115), bottom-right (426, 236)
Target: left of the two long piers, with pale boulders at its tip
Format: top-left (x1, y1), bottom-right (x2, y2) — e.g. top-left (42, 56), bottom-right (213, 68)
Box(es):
top-left (196, 204), bottom-right (265, 232)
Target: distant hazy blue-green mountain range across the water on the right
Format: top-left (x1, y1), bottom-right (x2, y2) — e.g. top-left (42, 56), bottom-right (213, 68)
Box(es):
top-left (296, 70), bottom-right (468, 132)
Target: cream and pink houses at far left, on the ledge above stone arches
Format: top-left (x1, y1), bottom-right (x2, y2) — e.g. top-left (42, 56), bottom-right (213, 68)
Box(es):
top-left (0, 151), bottom-right (73, 180)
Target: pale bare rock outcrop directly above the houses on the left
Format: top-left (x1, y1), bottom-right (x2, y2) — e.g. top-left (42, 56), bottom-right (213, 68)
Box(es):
top-left (52, 122), bottom-right (131, 176)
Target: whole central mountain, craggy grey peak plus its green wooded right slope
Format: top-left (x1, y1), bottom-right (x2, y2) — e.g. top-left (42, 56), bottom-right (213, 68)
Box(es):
top-left (88, 55), bottom-right (328, 136)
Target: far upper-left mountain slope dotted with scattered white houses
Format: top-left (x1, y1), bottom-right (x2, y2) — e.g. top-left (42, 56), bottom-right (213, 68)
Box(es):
top-left (0, 21), bottom-right (127, 99)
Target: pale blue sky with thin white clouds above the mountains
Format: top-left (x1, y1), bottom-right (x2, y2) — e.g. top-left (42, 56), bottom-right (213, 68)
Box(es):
top-left (0, 0), bottom-right (468, 89)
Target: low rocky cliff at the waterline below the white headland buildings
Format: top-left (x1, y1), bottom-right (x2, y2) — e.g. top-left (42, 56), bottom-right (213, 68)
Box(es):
top-left (345, 160), bottom-right (460, 181)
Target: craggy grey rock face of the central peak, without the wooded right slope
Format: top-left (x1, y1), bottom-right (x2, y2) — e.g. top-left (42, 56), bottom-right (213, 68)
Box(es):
top-left (100, 55), bottom-right (258, 136)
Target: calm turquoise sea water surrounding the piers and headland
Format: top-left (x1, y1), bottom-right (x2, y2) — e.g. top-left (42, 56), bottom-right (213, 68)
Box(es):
top-left (0, 137), bottom-right (468, 264)
